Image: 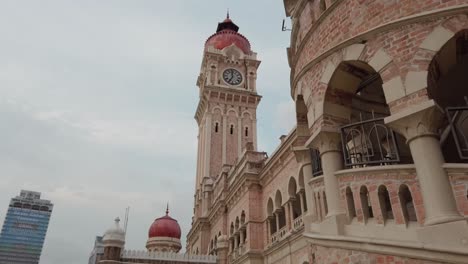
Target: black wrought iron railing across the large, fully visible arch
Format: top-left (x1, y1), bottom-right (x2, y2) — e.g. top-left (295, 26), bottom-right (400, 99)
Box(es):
top-left (341, 118), bottom-right (400, 167)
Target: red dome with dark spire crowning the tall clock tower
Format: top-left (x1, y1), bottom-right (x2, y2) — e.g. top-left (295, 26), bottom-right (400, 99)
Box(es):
top-left (205, 13), bottom-right (251, 54)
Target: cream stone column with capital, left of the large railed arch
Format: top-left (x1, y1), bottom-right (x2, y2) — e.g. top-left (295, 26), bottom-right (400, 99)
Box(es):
top-left (311, 131), bottom-right (345, 217)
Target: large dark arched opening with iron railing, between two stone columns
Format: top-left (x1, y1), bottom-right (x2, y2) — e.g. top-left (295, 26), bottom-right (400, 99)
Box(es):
top-left (324, 61), bottom-right (412, 168)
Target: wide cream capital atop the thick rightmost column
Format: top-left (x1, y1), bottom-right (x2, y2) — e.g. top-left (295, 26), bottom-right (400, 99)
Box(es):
top-left (385, 100), bottom-right (444, 143)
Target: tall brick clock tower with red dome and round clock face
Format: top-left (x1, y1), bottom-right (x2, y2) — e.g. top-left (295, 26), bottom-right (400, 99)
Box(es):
top-left (188, 14), bottom-right (261, 254)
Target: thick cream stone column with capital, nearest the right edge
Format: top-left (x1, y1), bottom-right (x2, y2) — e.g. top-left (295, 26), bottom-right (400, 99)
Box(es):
top-left (385, 100), bottom-right (463, 225)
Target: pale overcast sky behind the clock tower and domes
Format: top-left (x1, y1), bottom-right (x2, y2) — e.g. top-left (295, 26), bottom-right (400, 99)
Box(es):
top-left (0, 0), bottom-right (294, 264)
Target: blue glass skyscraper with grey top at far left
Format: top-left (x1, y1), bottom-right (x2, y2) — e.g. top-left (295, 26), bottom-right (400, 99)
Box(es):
top-left (0, 190), bottom-right (53, 264)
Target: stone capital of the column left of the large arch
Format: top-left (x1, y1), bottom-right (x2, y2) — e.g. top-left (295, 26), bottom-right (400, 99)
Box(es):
top-left (306, 129), bottom-right (342, 155)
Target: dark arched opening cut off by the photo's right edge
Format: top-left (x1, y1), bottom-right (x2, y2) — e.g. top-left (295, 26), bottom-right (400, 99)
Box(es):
top-left (427, 29), bottom-right (468, 163)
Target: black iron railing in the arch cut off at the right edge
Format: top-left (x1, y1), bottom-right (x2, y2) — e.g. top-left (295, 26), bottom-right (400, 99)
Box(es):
top-left (446, 98), bottom-right (468, 160)
